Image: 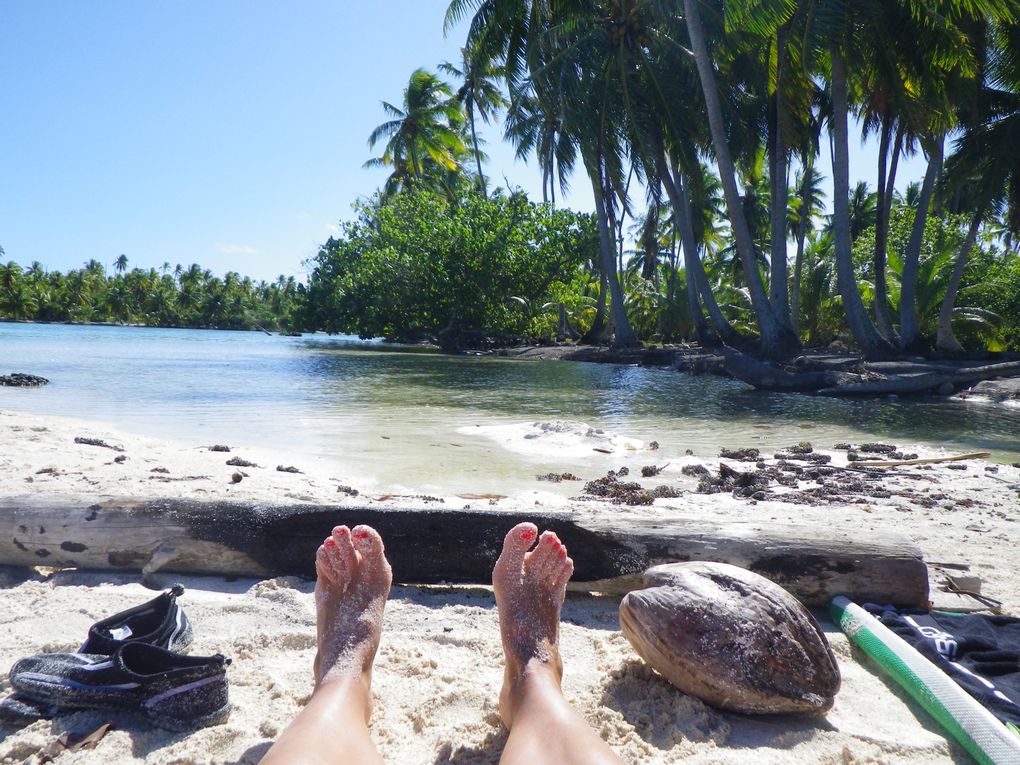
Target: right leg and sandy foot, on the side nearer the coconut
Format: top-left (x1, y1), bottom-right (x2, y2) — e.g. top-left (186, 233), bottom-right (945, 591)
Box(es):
top-left (493, 523), bottom-right (622, 765)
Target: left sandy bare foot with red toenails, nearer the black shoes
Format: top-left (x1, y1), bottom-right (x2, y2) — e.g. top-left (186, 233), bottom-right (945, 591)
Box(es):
top-left (314, 526), bottom-right (393, 687)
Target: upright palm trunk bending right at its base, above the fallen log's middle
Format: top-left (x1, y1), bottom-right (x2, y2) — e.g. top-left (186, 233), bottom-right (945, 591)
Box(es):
top-left (830, 45), bottom-right (893, 358)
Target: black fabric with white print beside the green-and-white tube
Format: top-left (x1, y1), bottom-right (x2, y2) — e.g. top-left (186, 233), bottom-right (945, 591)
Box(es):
top-left (865, 604), bottom-right (1020, 725)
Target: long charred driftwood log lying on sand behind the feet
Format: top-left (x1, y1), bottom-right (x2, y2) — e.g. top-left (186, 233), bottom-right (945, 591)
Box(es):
top-left (0, 497), bottom-right (928, 606)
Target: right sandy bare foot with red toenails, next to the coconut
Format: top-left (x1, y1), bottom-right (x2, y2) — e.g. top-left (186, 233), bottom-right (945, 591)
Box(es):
top-left (493, 523), bottom-right (573, 727)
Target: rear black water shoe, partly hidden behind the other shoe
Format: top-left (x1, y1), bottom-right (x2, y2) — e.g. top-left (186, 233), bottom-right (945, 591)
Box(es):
top-left (0, 584), bottom-right (193, 724)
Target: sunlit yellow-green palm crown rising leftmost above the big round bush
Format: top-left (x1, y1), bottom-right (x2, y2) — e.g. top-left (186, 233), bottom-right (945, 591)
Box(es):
top-left (365, 69), bottom-right (467, 191)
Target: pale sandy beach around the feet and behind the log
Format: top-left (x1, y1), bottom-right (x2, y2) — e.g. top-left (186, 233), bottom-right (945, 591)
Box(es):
top-left (0, 412), bottom-right (1020, 765)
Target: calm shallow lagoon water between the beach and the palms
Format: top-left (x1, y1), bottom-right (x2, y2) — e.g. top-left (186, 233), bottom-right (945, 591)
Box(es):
top-left (0, 323), bottom-right (1020, 494)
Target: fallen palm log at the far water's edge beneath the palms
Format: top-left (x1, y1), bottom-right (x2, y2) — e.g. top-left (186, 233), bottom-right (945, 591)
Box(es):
top-left (723, 351), bottom-right (1020, 396)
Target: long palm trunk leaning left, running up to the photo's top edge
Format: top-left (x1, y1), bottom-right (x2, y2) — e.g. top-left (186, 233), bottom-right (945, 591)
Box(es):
top-left (683, 0), bottom-right (800, 357)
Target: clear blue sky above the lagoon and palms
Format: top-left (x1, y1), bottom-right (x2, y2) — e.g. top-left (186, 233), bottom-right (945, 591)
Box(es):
top-left (0, 0), bottom-right (923, 279)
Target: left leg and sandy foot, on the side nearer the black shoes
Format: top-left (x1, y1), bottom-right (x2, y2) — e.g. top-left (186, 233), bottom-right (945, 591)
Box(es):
top-left (262, 526), bottom-right (393, 765)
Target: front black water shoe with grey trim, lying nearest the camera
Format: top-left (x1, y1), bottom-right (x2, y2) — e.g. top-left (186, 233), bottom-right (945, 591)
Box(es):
top-left (10, 643), bottom-right (231, 730)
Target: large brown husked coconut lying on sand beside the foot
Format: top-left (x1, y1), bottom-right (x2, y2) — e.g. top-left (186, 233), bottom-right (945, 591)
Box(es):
top-left (620, 562), bottom-right (839, 714)
